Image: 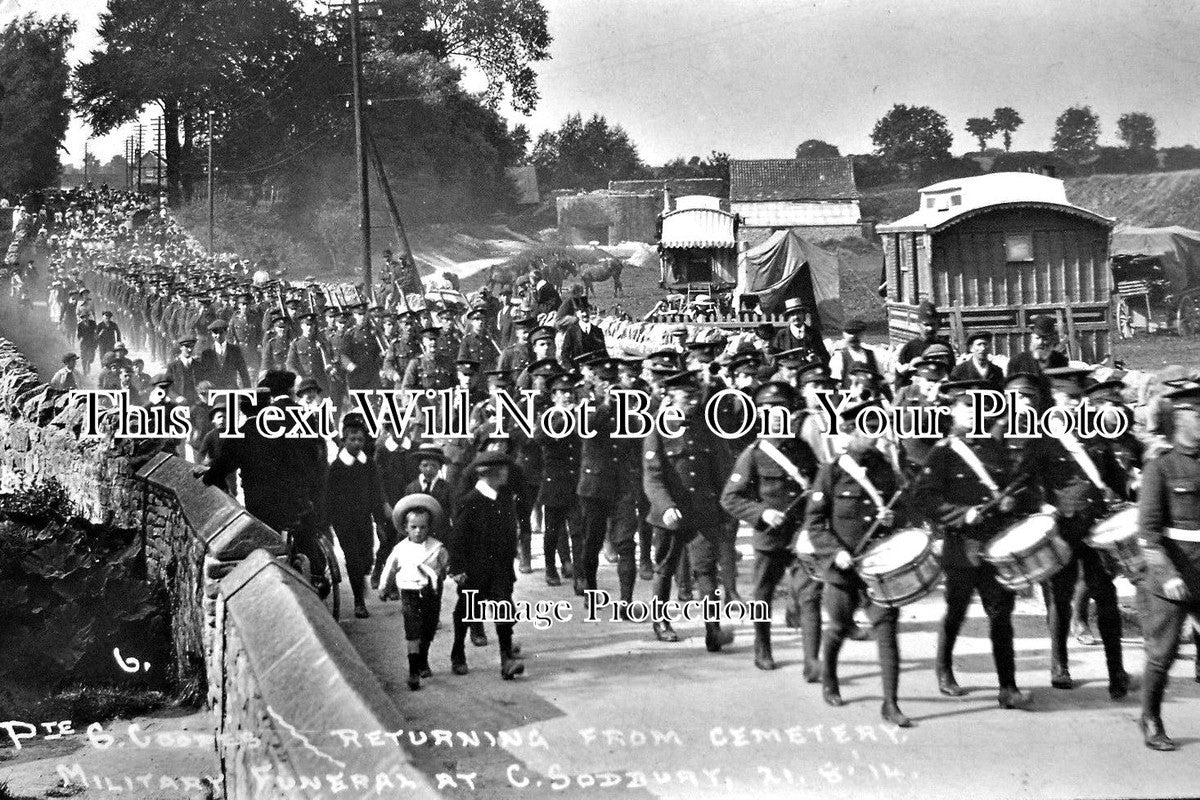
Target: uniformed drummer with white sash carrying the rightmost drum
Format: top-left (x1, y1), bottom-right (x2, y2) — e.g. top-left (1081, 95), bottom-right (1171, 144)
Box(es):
top-left (1036, 367), bottom-right (1129, 700)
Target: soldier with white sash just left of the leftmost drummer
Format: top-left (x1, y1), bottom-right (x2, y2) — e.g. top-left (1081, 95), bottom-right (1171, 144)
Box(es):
top-left (721, 383), bottom-right (817, 674)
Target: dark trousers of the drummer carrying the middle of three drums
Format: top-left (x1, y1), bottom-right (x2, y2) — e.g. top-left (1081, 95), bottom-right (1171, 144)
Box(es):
top-left (937, 564), bottom-right (1016, 688)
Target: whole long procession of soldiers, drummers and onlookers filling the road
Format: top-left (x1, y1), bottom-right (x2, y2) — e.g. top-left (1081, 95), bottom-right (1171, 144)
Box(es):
top-left (11, 191), bottom-right (1200, 750)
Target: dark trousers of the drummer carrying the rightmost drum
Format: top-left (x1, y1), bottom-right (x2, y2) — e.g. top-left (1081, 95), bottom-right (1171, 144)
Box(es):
top-left (1044, 517), bottom-right (1124, 679)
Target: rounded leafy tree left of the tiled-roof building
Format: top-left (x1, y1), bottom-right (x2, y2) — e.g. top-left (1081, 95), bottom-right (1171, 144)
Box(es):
top-left (532, 114), bottom-right (646, 188)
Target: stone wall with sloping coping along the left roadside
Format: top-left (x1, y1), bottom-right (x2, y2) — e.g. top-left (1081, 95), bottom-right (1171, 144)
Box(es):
top-left (0, 339), bottom-right (437, 800)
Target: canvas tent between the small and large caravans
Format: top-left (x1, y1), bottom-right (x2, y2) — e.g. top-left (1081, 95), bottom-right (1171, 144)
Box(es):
top-left (738, 229), bottom-right (842, 331)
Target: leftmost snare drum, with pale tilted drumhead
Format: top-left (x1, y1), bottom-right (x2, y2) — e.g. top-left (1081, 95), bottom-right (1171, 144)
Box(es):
top-left (858, 528), bottom-right (942, 608)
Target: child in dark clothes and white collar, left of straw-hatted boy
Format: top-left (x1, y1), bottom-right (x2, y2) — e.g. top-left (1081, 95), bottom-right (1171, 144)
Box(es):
top-left (326, 414), bottom-right (384, 619)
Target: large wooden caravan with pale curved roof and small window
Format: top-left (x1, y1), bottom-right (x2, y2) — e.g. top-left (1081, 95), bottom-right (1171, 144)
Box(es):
top-left (877, 173), bottom-right (1114, 363)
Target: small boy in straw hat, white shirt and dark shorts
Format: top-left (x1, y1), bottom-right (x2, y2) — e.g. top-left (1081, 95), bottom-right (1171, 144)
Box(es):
top-left (379, 494), bottom-right (450, 691)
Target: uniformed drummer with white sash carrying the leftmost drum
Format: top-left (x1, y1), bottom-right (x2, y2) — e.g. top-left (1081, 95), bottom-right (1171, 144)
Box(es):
top-left (804, 399), bottom-right (912, 728)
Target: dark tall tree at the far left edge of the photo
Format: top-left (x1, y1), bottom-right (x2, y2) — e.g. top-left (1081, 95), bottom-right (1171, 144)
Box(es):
top-left (0, 14), bottom-right (76, 197)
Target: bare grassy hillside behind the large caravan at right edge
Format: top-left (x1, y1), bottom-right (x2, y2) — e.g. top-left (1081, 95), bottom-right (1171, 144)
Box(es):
top-left (1067, 169), bottom-right (1200, 229)
